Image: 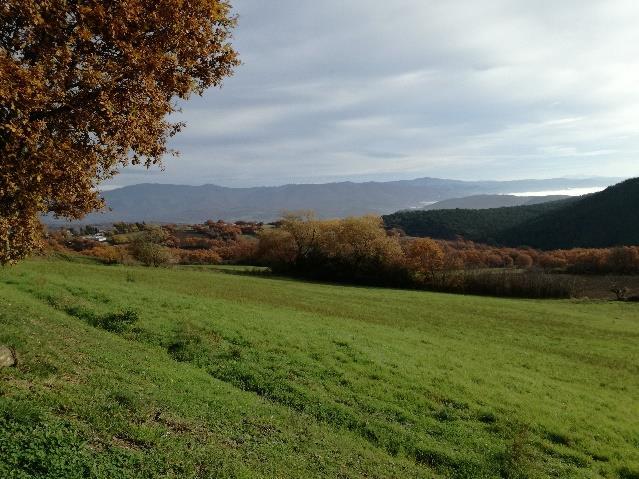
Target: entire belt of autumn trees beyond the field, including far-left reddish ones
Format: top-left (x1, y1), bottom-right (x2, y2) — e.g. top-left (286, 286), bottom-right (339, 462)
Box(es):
top-left (47, 213), bottom-right (639, 282)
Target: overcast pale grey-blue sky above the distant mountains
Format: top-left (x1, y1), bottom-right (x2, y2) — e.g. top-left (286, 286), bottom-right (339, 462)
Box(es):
top-left (107, 0), bottom-right (639, 186)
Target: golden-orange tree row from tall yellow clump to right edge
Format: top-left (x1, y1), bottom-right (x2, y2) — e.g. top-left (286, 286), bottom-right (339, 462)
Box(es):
top-left (257, 213), bottom-right (639, 278)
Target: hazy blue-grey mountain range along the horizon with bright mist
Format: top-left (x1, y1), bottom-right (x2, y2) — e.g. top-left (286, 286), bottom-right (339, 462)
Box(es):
top-left (45, 178), bottom-right (619, 224)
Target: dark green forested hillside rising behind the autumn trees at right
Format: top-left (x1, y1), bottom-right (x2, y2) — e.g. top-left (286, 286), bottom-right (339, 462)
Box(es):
top-left (384, 178), bottom-right (639, 249)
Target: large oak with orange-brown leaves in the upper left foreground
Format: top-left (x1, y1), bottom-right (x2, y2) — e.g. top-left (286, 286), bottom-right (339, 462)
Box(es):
top-left (0, 0), bottom-right (238, 263)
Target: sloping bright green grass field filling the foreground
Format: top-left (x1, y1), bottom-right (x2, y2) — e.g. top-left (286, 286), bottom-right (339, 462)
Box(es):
top-left (0, 259), bottom-right (639, 479)
